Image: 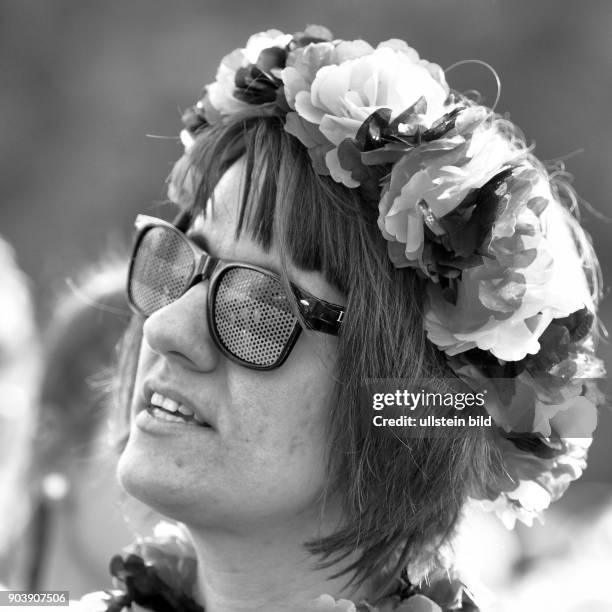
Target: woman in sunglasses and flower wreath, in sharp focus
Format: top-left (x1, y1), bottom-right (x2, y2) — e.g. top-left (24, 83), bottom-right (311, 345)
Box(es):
top-left (87, 27), bottom-right (603, 612)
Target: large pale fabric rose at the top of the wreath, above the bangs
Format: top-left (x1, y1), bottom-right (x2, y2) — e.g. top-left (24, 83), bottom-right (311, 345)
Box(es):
top-left (285, 40), bottom-right (449, 187)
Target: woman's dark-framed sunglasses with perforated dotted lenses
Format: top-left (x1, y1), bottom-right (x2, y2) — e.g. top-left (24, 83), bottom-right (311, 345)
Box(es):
top-left (127, 215), bottom-right (344, 370)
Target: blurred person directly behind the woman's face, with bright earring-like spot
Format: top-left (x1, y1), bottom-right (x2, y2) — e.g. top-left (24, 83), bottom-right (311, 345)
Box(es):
top-left (21, 258), bottom-right (155, 598)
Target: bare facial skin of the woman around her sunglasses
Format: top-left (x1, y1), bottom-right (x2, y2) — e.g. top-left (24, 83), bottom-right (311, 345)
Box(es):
top-left (119, 161), bottom-right (344, 530)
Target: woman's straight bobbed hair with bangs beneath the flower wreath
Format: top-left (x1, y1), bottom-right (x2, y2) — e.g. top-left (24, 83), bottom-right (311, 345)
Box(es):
top-left (118, 117), bottom-right (497, 586)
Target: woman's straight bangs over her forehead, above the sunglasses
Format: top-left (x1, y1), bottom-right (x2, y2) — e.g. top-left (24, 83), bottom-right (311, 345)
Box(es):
top-left (169, 117), bottom-right (377, 294)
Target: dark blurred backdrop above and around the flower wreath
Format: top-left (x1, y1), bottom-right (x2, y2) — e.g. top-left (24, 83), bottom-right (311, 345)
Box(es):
top-left (0, 0), bottom-right (612, 609)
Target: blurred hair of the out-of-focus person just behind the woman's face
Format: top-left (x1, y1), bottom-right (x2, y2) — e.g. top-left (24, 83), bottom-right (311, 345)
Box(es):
top-left (34, 254), bottom-right (130, 473)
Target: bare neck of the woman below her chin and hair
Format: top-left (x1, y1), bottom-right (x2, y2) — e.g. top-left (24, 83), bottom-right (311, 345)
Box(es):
top-left (190, 523), bottom-right (366, 612)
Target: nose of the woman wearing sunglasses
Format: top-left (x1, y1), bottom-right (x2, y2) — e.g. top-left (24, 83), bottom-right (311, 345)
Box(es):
top-left (143, 281), bottom-right (221, 371)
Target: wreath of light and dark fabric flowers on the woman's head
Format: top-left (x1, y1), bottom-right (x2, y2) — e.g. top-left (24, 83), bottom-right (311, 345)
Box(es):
top-left (170, 26), bottom-right (604, 526)
